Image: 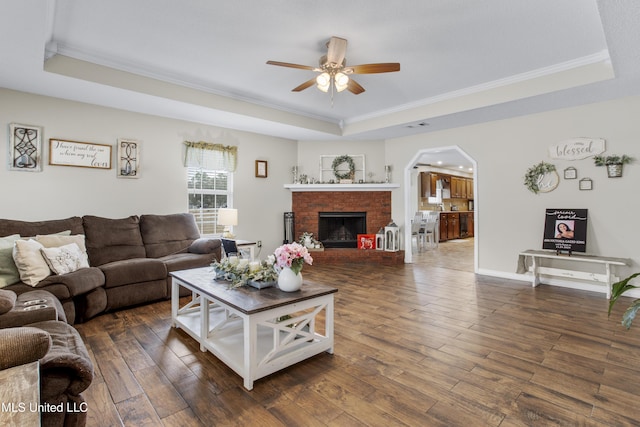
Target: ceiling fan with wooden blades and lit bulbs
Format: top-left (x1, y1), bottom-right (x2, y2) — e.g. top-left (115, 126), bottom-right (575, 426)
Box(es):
top-left (267, 37), bottom-right (400, 95)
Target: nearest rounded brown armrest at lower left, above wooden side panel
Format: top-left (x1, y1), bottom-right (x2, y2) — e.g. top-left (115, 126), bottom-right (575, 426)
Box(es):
top-left (0, 326), bottom-right (52, 369)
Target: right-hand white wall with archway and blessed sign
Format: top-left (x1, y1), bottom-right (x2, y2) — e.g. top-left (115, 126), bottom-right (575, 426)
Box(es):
top-left (385, 97), bottom-right (640, 277)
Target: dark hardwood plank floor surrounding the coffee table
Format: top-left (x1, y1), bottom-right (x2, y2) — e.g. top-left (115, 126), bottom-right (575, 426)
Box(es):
top-left (77, 239), bottom-right (640, 427)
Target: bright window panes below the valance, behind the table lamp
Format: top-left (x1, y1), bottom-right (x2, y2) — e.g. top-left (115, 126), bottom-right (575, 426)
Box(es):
top-left (187, 167), bottom-right (233, 235)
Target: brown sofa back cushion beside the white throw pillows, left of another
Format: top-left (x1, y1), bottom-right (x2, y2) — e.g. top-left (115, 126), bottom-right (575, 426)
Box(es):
top-left (82, 215), bottom-right (146, 266)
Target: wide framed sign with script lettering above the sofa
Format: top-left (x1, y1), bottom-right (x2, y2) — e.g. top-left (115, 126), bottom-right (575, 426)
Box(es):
top-left (49, 138), bottom-right (111, 169)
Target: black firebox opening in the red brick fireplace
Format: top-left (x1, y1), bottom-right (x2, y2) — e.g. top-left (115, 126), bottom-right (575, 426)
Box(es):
top-left (318, 212), bottom-right (367, 248)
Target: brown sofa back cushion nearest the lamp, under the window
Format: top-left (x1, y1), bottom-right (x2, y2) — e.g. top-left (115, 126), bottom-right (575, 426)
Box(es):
top-left (140, 213), bottom-right (200, 258)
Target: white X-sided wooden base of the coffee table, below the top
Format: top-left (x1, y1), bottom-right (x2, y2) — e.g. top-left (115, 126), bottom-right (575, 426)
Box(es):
top-left (172, 277), bottom-right (334, 390)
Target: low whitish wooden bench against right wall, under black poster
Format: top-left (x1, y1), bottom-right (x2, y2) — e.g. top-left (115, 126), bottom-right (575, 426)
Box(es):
top-left (518, 249), bottom-right (631, 299)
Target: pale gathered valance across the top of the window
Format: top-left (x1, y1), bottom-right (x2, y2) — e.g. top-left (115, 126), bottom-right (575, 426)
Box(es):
top-left (184, 141), bottom-right (238, 172)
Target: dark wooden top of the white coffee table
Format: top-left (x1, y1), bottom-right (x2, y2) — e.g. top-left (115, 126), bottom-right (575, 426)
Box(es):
top-left (170, 267), bottom-right (338, 314)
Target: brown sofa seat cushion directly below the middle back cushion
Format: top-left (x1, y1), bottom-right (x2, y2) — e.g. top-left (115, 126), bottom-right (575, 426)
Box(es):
top-left (100, 258), bottom-right (167, 288)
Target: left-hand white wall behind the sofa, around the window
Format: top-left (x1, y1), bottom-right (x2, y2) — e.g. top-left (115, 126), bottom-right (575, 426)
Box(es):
top-left (0, 89), bottom-right (297, 255)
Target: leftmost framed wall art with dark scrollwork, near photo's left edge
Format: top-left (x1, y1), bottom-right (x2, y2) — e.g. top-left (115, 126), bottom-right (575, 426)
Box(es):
top-left (8, 123), bottom-right (42, 172)
